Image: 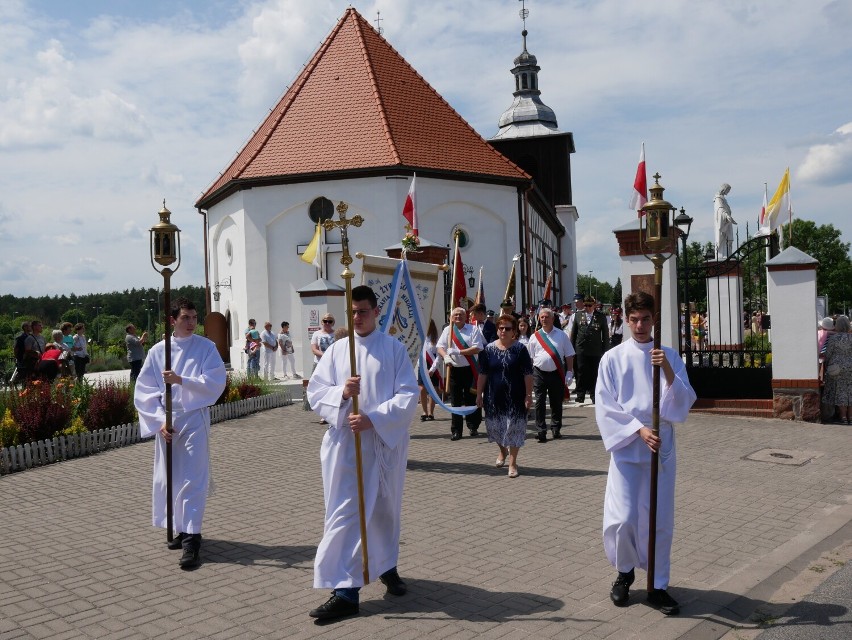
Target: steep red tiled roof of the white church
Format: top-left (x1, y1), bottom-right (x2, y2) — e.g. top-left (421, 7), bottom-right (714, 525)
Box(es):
top-left (196, 8), bottom-right (530, 208)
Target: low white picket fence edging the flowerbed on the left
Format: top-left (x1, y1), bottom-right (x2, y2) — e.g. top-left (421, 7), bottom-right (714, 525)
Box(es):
top-left (0, 390), bottom-right (293, 476)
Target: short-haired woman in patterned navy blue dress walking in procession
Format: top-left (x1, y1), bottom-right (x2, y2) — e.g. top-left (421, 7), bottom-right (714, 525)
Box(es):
top-left (476, 315), bottom-right (532, 478)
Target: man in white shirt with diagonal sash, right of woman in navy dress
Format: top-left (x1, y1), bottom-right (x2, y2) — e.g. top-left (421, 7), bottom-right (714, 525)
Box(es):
top-left (527, 307), bottom-right (574, 442)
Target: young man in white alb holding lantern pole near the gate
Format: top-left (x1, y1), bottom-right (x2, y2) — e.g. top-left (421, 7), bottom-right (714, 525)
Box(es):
top-left (595, 293), bottom-right (695, 615)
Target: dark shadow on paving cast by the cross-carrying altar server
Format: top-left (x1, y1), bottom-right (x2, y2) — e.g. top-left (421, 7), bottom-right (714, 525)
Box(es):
top-left (372, 578), bottom-right (574, 622)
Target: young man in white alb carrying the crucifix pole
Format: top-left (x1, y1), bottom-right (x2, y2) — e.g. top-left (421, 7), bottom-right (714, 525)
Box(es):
top-left (307, 285), bottom-right (418, 619)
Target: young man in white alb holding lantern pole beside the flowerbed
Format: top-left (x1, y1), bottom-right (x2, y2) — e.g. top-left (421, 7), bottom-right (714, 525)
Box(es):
top-left (134, 298), bottom-right (227, 569)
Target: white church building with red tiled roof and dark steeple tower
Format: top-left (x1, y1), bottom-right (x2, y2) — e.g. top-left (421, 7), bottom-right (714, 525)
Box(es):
top-left (196, 7), bottom-right (577, 368)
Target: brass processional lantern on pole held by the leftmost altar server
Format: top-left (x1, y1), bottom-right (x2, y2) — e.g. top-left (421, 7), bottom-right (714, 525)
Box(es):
top-left (149, 200), bottom-right (180, 542)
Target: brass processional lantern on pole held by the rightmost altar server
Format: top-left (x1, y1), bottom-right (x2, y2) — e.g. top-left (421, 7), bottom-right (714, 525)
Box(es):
top-left (639, 173), bottom-right (676, 593)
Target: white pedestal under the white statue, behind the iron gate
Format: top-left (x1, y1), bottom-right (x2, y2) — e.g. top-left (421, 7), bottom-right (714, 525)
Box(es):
top-left (707, 261), bottom-right (743, 351)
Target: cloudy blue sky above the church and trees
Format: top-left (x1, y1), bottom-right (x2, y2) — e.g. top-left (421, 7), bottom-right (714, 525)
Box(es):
top-left (0, 0), bottom-right (852, 295)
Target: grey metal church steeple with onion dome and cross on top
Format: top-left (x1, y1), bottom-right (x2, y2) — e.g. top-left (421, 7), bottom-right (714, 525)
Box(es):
top-left (492, 9), bottom-right (561, 140)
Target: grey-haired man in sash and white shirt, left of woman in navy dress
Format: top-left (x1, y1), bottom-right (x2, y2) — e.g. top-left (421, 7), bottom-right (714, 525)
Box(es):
top-left (438, 307), bottom-right (485, 440)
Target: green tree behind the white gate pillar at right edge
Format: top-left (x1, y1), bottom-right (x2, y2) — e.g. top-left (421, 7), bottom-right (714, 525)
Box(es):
top-left (783, 218), bottom-right (852, 312)
